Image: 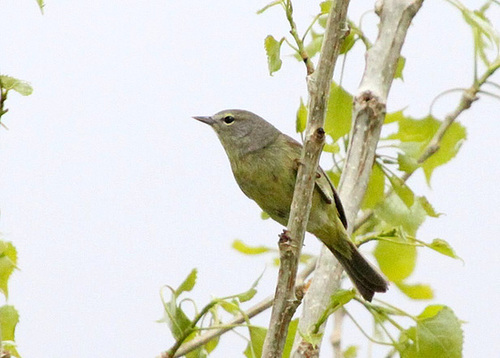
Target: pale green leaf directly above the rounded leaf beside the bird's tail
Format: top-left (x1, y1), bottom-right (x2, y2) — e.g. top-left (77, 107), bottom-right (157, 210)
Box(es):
top-left (374, 194), bottom-right (427, 236)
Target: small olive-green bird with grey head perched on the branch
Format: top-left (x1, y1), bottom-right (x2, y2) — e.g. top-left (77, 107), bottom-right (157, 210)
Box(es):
top-left (193, 109), bottom-right (387, 301)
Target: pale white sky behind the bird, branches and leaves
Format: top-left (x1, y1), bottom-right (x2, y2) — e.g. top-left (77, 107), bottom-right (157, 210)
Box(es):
top-left (0, 0), bottom-right (500, 358)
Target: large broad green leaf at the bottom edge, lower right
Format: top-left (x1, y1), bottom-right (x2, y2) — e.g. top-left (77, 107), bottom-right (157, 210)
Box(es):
top-left (398, 305), bottom-right (463, 358)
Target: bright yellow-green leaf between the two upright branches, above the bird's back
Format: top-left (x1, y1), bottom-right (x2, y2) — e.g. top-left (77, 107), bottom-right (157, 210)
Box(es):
top-left (325, 82), bottom-right (353, 141)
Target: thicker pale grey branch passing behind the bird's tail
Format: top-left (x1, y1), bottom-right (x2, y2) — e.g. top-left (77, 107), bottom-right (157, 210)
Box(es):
top-left (292, 0), bottom-right (423, 358)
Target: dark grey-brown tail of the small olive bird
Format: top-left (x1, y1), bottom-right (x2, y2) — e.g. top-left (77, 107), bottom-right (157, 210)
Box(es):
top-left (330, 241), bottom-right (388, 302)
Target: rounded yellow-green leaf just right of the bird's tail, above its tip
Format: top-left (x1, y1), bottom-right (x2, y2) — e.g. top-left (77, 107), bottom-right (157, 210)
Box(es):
top-left (373, 232), bottom-right (417, 282)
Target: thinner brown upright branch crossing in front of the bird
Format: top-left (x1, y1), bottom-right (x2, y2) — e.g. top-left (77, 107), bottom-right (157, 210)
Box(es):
top-left (262, 0), bottom-right (349, 358)
